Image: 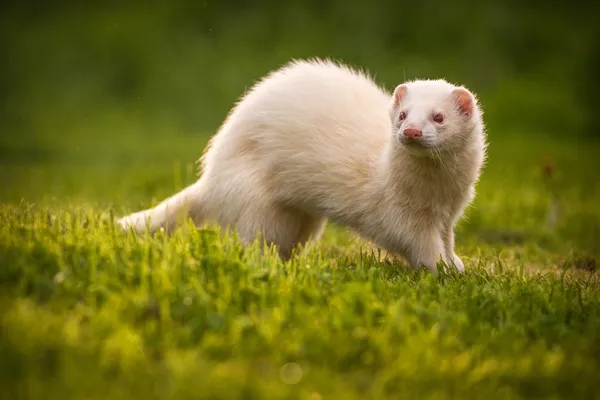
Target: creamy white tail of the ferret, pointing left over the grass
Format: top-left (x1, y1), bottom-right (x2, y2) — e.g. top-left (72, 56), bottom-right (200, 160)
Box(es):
top-left (117, 181), bottom-right (206, 233)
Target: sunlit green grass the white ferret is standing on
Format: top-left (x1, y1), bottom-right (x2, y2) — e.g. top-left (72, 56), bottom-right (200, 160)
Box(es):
top-left (0, 130), bottom-right (600, 400)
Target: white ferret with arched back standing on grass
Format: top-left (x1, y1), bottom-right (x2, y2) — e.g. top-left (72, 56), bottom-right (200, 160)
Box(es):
top-left (119, 59), bottom-right (486, 273)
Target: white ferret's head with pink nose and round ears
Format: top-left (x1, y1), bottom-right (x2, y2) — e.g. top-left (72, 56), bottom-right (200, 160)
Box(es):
top-left (390, 79), bottom-right (481, 155)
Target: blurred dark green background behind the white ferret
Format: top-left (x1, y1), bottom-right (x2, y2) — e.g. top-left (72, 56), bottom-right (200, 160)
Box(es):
top-left (0, 0), bottom-right (600, 204)
